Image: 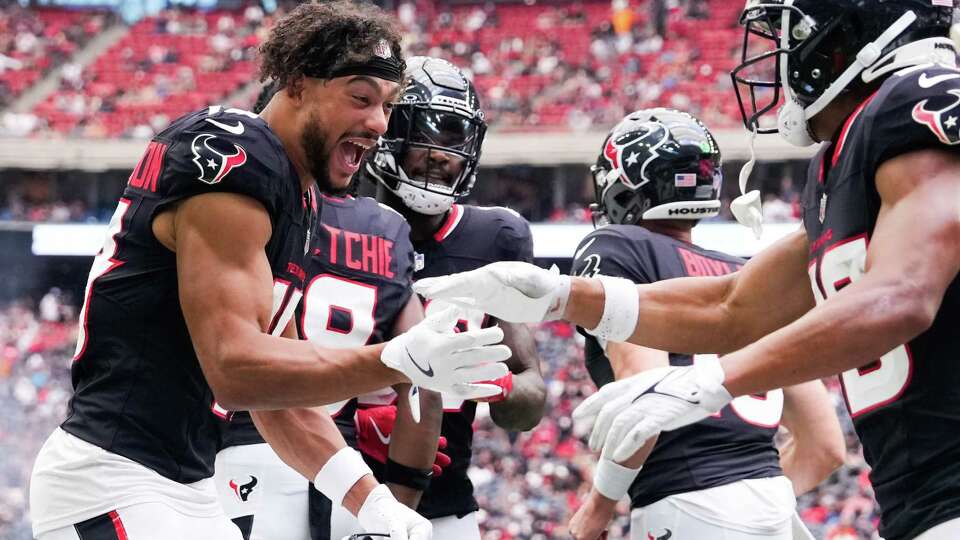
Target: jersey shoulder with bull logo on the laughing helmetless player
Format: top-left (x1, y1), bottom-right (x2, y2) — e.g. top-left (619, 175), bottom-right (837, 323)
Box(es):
top-left (155, 106), bottom-right (292, 217)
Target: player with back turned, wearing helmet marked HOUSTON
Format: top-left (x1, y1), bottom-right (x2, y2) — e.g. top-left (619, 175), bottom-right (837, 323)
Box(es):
top-left (570, 109), bottom-right (846, 540)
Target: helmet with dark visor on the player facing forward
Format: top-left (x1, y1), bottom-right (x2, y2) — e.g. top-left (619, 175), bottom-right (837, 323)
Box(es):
top-left (366, 56), bottom-right (487, 215)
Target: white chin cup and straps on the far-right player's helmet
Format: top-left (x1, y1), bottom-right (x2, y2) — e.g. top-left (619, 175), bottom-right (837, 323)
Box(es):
top-left (777, 11), bottom-right (917, 146)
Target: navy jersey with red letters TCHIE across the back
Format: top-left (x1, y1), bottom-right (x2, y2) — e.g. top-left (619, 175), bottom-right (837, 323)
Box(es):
top-left (223, 195), bottom-right (413, 448)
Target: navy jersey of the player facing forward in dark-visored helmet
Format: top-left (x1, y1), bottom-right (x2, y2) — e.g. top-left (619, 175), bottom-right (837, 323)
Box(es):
top-left (368, 204), bottom-right (533, 519)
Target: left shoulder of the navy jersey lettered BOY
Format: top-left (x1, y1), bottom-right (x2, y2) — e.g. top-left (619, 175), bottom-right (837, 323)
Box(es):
top-left (571, 225), bottom-right (656, 283)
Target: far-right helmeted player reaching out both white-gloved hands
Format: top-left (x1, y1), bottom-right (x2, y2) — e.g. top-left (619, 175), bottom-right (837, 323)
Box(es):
top-left (414, 0), bottom-right (960, 540)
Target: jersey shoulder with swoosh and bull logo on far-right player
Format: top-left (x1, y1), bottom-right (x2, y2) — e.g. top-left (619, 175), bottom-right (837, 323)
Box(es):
top-left (857, 64), bottom-right (960, 170)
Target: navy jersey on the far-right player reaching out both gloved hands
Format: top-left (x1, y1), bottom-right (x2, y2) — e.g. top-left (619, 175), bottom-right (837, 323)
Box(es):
top-left (803, 65), bottom-right (960, 540)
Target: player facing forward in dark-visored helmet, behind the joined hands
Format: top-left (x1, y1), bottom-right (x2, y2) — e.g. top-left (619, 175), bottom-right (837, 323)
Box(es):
top-left (367, 57), bottom-right (546, 540)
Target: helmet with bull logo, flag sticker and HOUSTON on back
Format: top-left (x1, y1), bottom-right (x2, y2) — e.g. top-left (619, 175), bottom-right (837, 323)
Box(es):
top-left (590, 109), bottom-right (723, 226)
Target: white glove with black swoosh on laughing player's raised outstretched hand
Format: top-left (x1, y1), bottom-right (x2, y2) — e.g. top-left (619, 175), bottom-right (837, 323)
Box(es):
top-left (380, 307), bottom-right (511, 400)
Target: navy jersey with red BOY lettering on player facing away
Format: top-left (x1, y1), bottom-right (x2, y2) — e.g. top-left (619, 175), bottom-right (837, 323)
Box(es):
top-left (572, 225), bottom-right (783, 508)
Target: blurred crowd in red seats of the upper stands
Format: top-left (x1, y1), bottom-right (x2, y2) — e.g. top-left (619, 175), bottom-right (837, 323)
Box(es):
top-left (0, 0), bottom-right (742, 138)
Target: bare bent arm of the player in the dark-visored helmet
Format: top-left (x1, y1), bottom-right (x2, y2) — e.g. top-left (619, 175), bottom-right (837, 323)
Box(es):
top-left (490, 322), bottom-right (547, 431)
